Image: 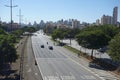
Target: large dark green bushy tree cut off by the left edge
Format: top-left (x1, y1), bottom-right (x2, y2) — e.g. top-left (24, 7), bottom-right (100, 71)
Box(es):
top-left (0, 35), bottom-right (18, 65)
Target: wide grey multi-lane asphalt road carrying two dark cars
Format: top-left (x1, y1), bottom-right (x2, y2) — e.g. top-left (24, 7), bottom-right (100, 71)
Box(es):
top-left (32, 33), bottom-right (101, 80)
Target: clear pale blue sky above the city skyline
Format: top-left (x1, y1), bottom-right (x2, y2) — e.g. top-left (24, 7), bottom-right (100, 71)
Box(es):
top-left (0, 0), bottom-right (120, 23)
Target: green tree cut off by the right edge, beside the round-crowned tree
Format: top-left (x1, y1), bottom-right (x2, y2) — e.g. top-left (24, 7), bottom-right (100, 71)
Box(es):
top-left (108, 33), bottom-right (120, 62)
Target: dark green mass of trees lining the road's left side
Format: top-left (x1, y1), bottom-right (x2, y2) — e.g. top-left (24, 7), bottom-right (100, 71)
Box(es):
top-left (0, 25), bottom-right (36, 69)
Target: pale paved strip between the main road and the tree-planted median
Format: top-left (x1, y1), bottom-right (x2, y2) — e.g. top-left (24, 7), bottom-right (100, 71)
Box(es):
top-left (56, 47), bottom-right (120, 80)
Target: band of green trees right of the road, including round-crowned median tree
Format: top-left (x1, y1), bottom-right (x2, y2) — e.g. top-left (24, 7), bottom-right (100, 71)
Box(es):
top-left (52, 25), bottom-right (120, 58)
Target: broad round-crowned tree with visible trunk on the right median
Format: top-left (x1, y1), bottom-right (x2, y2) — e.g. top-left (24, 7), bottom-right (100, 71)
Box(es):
top-left (76, 29), bottom-right (109, 58)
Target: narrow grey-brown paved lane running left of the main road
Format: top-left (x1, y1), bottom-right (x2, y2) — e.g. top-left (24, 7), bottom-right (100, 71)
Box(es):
top-left (24, 38), bottom-right (42, 80)
